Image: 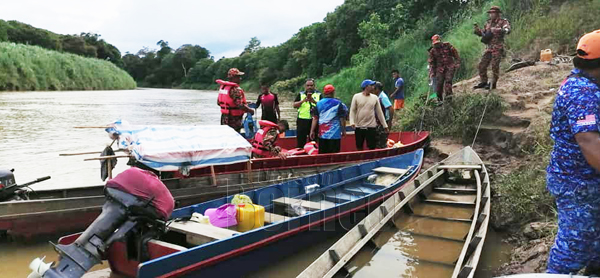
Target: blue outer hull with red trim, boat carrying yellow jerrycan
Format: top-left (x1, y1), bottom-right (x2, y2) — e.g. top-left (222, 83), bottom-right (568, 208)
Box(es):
top-left (103, 151), bottom-right (422, 277)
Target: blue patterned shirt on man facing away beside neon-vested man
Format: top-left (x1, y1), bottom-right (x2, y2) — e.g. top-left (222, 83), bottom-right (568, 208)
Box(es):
top-left (312, 97), bottom-right (348, 139)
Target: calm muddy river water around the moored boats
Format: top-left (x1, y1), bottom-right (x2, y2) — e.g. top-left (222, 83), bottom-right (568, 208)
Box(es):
top-left (0, 89), bottom-right (507, 277)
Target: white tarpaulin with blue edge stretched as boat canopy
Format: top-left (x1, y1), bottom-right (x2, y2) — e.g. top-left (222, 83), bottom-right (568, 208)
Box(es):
top-left (106, 121), bottom-right (252, 173)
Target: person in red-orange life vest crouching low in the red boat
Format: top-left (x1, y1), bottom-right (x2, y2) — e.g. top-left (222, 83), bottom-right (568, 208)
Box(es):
top-left (252, 120), bottom-right (289, 159)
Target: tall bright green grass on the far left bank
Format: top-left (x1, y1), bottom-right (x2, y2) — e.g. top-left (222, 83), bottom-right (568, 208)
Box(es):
top-left (0, 42), bottom-right (136, 91)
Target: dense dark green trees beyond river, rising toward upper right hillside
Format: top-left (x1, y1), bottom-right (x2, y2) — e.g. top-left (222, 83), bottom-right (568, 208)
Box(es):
top-left (123, 0), bottom-right (468, 90)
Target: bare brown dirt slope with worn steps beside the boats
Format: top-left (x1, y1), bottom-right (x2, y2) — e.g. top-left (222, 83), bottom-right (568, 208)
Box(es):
top-left (426, 62), bottom-right (572, 275)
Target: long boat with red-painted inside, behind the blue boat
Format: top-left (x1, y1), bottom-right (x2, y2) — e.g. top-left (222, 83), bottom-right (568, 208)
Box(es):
top-left (0, 131), bottom-right (429, 239)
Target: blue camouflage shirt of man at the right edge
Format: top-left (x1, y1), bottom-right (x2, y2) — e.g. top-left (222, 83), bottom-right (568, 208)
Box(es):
top-left (546, 69), bottom-right (600, 198)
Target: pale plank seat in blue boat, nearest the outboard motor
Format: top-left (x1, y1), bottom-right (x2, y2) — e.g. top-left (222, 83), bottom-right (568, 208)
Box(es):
top-left (168, 221), bottom-right (238, 245)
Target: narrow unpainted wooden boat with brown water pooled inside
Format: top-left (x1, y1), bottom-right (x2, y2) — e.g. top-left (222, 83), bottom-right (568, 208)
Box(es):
top-left (298, 147), bottom-right (490, 278)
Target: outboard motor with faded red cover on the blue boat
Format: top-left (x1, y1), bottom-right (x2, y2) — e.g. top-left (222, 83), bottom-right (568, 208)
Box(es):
top-left (29, 168), bottom-right (174, 278)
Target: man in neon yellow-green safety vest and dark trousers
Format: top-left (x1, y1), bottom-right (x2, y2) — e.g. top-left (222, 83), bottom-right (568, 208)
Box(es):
top-left (294, 78), bottom-right (321, 148)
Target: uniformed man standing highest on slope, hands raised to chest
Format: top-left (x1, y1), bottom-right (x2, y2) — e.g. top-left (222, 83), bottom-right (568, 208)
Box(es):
top-left (473, 6), bottom-right (510, 89)
